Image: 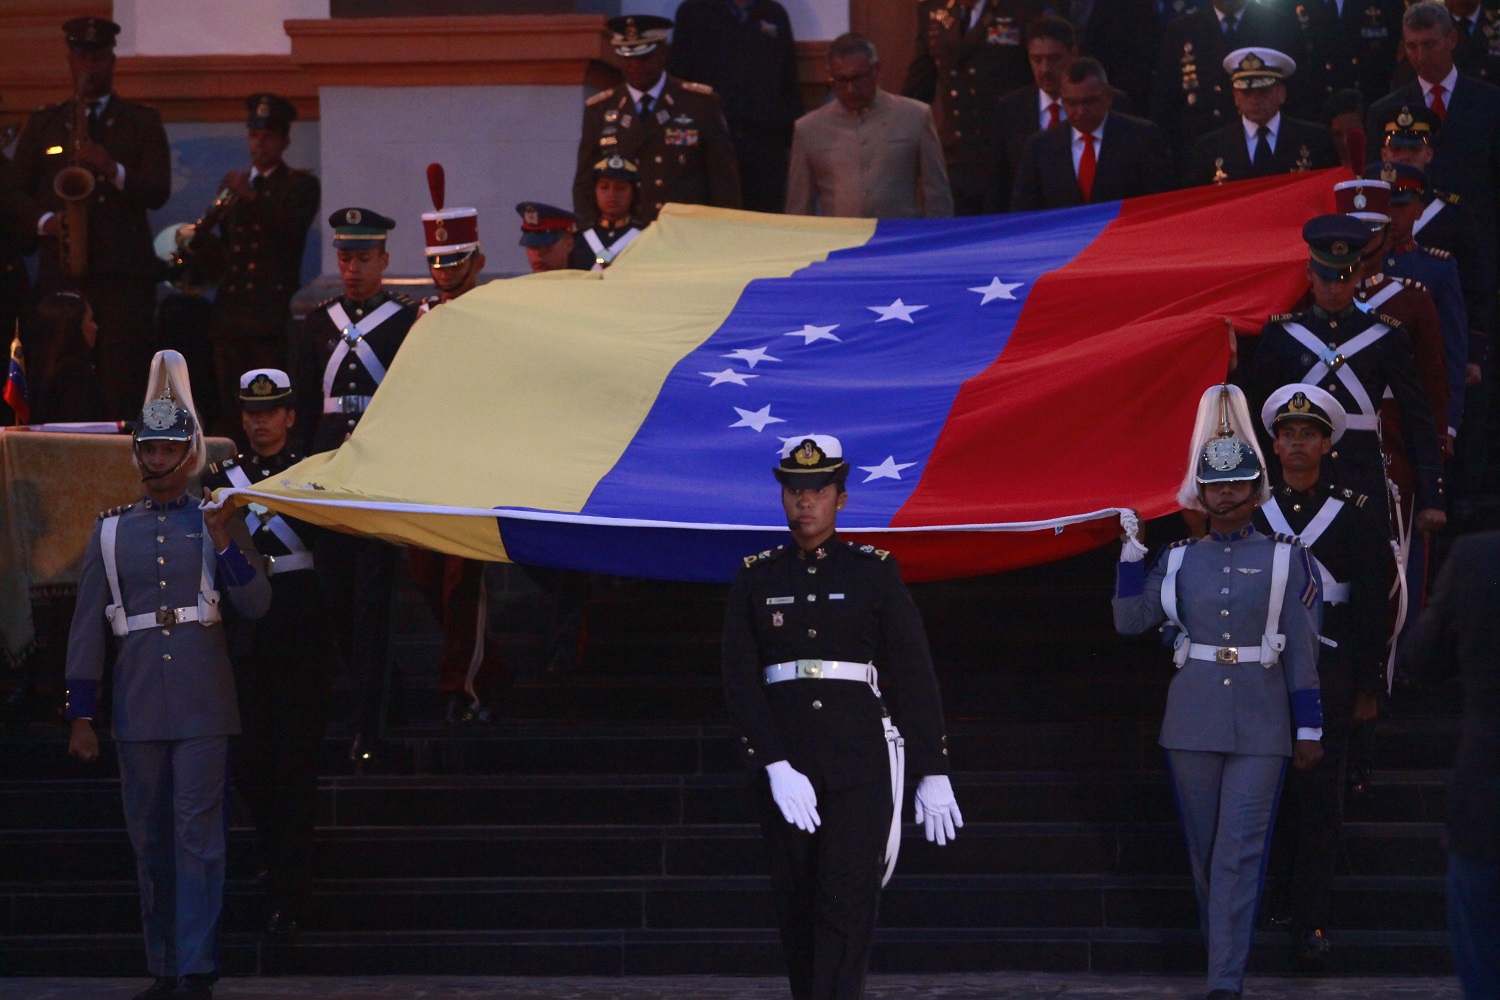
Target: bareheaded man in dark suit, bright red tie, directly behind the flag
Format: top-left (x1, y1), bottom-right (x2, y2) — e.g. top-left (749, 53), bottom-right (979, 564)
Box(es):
top-left (1011, 57), bottom-right (1172, 211)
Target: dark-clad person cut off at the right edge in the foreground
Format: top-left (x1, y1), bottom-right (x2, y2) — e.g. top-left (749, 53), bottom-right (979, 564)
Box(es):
top-left (1401, 531), bottom-right (1500, 997)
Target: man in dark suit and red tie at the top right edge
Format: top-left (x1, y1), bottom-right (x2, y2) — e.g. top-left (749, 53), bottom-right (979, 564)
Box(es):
top-left (1365, 0), bottom-right (1500, 257)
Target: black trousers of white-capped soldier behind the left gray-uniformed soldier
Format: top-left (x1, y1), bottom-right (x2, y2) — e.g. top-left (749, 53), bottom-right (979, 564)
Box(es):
top-left (233, 570), bottom-right (338, 913)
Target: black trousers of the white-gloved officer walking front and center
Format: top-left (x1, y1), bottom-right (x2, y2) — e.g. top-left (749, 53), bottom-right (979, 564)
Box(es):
top-left (756, 774), bottom-right (891, 1000)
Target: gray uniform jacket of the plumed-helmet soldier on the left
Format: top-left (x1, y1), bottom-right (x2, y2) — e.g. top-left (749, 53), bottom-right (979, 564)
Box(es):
top-left (68, 493), bottom-right (272, 741)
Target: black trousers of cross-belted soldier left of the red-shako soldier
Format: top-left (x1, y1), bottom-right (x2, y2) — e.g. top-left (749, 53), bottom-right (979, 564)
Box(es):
top-left (315, 531), bottom-right (402, 738)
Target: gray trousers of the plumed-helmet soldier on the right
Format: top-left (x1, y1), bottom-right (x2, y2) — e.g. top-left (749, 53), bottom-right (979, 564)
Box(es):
top-left (1167, 750), bottom-right (1287, 991)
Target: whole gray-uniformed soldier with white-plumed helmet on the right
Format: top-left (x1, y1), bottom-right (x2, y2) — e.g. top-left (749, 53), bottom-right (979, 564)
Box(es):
top-left (1115, 385), bottom-right (1323, 1000)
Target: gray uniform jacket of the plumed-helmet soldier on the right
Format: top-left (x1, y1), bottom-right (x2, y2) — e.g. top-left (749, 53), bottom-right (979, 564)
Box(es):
top-left (1113, 526), bottom-right (1323, 757)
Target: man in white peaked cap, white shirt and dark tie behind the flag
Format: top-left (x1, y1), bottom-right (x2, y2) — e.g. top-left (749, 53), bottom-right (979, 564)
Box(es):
top-left (1182, 48), bottom-right (1338, 186)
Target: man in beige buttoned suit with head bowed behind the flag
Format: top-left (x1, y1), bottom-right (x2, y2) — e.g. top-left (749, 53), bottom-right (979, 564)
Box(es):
top-left (786, 33), bottom-right (953, 219)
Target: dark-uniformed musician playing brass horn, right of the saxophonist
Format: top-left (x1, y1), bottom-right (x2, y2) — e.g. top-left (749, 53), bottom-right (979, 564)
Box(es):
top-left (209, 93), bottom-right (321, 436)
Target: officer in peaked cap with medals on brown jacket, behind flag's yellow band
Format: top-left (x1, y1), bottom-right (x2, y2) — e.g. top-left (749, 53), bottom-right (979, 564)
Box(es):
top-left (573, 15), bottom-right (741, 222)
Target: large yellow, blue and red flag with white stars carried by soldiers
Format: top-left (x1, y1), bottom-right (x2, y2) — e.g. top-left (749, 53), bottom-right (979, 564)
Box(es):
top-left (237, 171), bottom-right (1335, 580)
